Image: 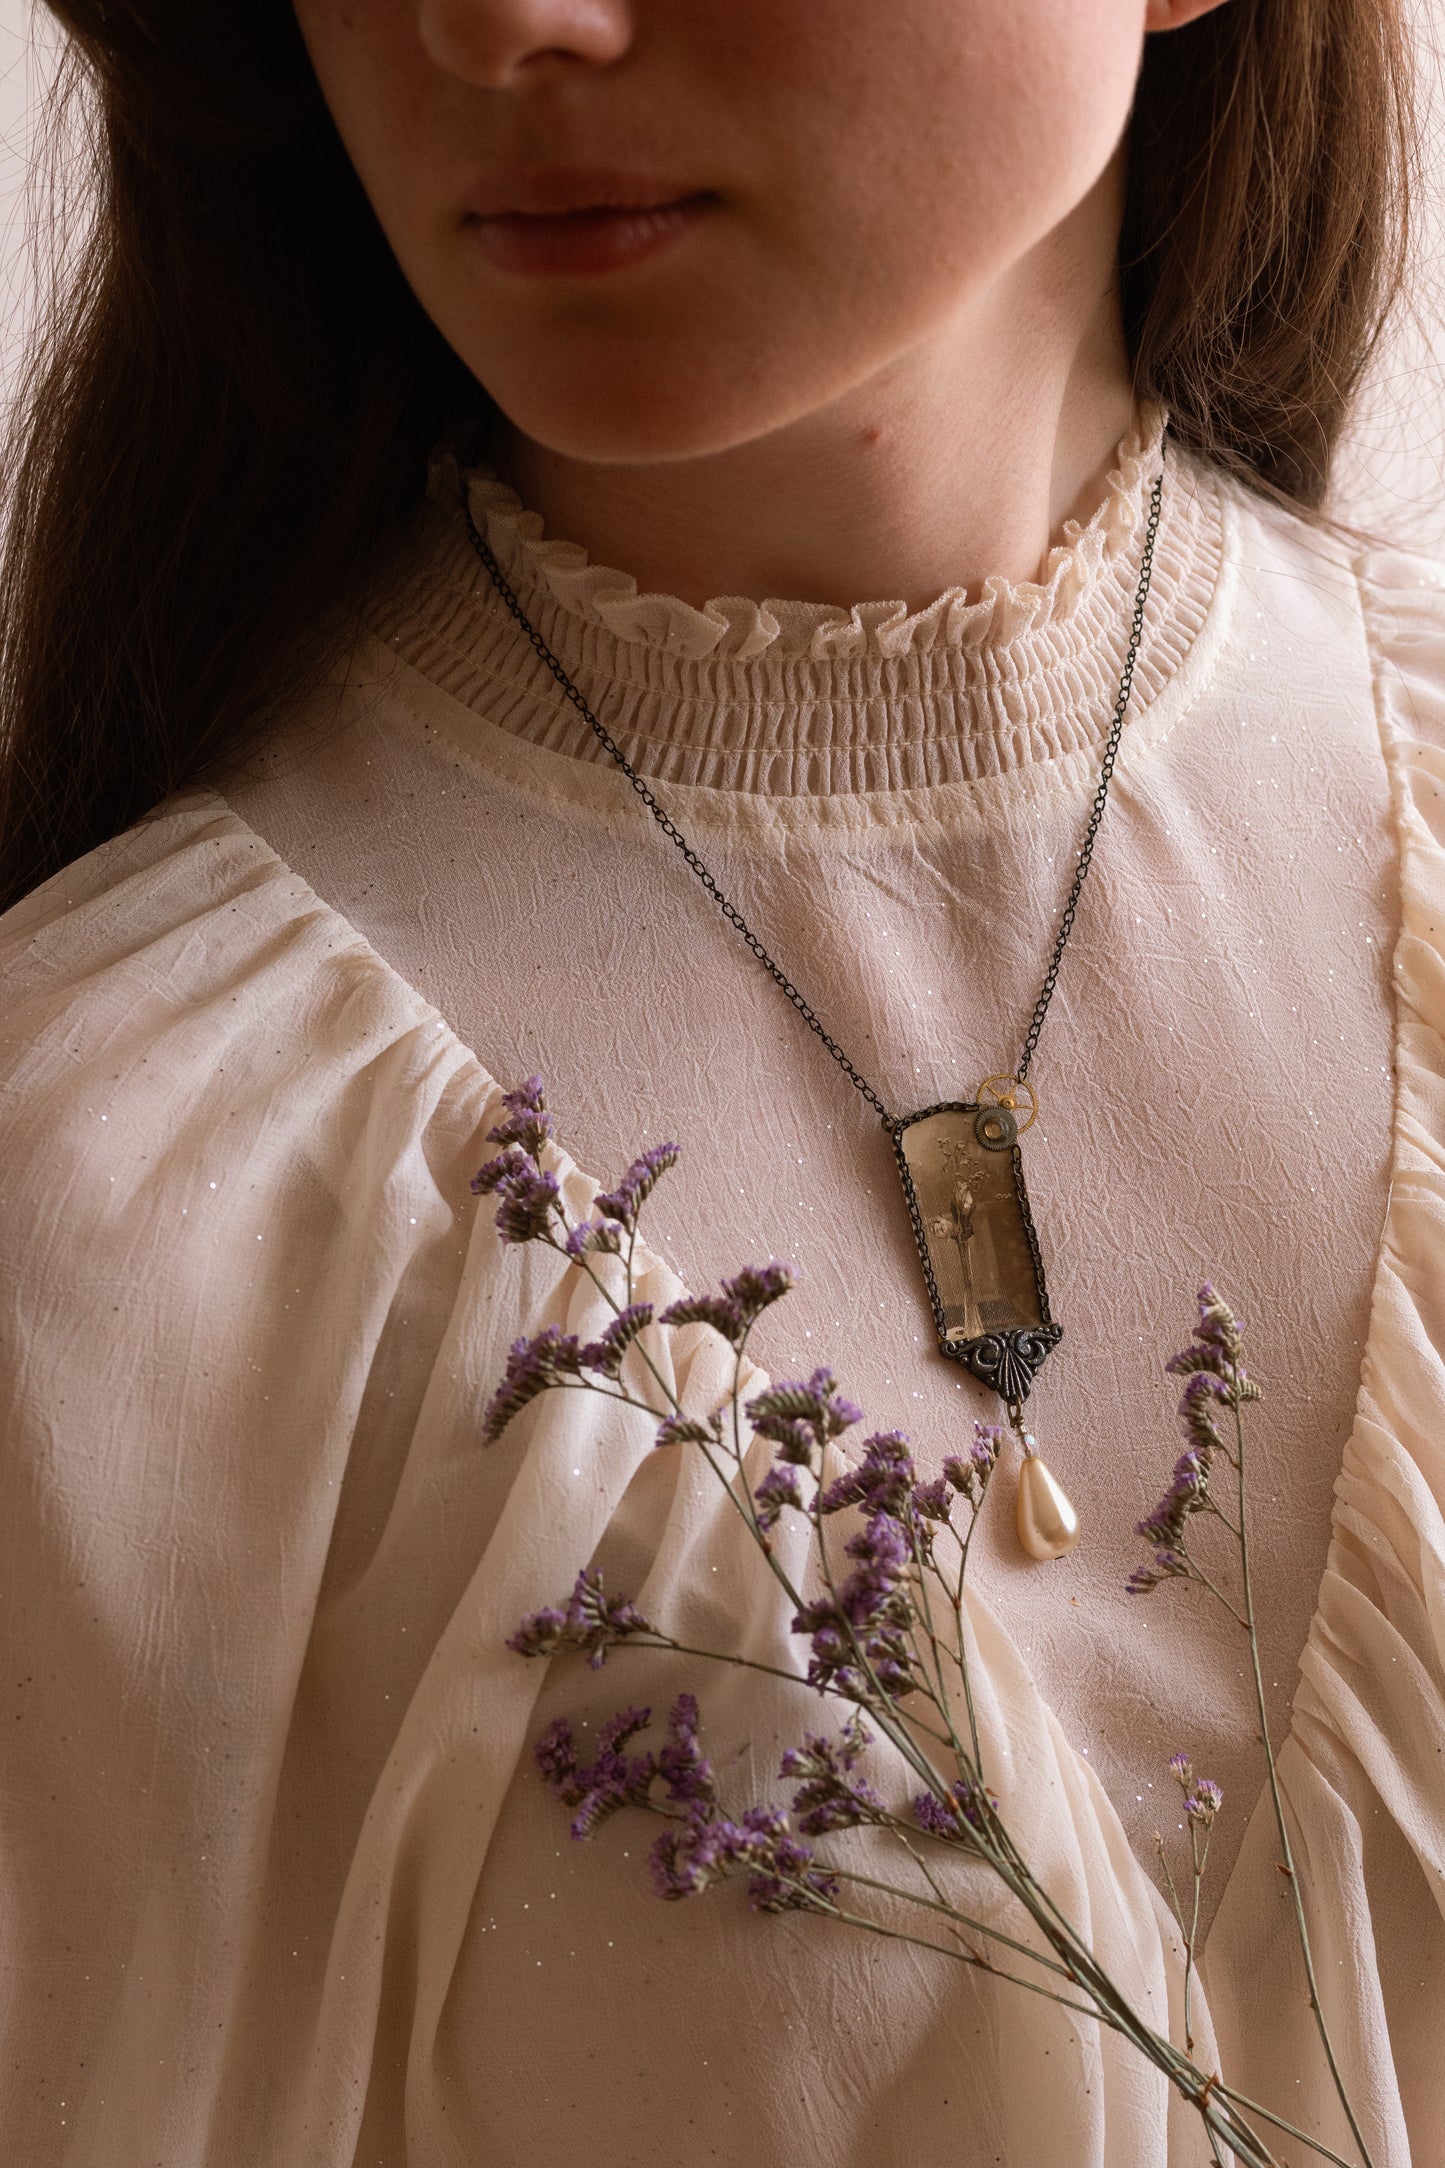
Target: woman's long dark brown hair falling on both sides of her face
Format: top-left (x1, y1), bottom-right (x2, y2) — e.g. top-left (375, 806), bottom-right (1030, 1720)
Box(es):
top-left (0, 0), bottom-right (1415, 908)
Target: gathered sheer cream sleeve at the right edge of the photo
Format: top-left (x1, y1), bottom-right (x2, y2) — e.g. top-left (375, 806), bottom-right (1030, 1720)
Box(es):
top-left (1205, 553), bottom-right (1445, 2168)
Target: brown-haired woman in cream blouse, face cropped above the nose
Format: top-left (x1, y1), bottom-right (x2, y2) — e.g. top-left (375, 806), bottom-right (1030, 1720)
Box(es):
top-left (0, 0), bottom-right (1445, 2168)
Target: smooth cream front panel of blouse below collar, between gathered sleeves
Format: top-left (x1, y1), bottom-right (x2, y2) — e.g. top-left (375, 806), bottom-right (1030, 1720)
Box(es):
top-left (234, 598), bottom-right (1397, 1886)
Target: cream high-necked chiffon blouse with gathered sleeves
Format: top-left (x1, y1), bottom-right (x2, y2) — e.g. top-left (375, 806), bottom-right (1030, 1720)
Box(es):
top-left (0, 410), bottom-right (1445, 2168)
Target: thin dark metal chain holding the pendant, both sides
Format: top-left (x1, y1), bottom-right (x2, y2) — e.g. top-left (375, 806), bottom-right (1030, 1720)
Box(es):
top-left (461, 473), bottom-right (1163, 1130)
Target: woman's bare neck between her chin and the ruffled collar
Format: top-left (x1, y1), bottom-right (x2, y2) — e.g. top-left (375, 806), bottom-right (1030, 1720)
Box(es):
top-left (496, 176), bottom-right (1133, 609)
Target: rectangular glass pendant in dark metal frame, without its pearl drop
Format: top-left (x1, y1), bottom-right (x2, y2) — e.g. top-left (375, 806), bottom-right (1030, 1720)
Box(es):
top-left (893, 1101), bottom-right (1064, 1403)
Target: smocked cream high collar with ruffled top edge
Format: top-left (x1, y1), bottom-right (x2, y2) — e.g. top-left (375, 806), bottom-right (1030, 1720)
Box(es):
top-left (375, 401), bottom-right (1222, 796)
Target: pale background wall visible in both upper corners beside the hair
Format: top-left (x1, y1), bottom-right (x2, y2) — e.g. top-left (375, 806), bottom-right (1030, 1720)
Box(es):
top-left (0, 0), bottom-right (1445, 555)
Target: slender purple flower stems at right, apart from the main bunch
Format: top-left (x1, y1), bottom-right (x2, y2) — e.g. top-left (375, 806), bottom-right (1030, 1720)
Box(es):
top-left (1124, 1281), bottom-right (1371, 2168)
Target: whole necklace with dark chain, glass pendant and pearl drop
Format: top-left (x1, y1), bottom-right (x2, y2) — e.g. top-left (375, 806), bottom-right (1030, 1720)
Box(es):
top-left (461, 468), bottom-right (1163, 1559)
